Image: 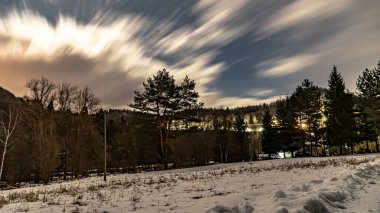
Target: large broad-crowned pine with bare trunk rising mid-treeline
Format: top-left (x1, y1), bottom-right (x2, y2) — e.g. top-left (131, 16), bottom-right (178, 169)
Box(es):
top-left (130, 69), bottom-right (203, 168)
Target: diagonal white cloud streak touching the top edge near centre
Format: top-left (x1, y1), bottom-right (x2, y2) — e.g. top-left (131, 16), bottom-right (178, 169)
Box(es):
top-left (158, 0), bottom-right (249, 55)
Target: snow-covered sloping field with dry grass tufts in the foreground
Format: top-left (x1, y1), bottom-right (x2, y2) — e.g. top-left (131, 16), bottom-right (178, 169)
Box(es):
top-left (0, 155), bottom-right (380, 213)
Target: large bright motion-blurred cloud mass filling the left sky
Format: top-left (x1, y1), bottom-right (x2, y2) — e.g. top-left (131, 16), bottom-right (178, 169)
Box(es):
top-left (0, 11), bottom-right (167, 106)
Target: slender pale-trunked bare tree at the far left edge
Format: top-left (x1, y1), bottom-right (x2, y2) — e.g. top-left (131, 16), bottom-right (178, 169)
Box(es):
top-left (0, 106), bottom-right (19, 180)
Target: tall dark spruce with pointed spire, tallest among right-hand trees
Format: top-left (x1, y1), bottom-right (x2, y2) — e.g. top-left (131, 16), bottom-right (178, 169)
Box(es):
top-left (324, 66), bottom-right (354, 155)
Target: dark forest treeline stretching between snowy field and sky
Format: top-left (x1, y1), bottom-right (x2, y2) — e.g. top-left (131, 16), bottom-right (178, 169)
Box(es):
top-left (0, 63), bottom-right (380, 184)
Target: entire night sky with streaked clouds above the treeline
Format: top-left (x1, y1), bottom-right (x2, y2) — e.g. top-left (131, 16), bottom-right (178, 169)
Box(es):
top-left (0, 0), bottom-right (380, 107)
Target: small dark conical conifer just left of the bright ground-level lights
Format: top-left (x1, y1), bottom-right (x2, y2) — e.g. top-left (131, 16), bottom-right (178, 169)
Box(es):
top-left (261, 110), bottom-right (279, 158)
